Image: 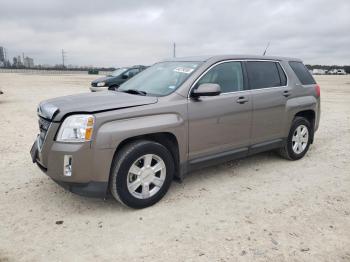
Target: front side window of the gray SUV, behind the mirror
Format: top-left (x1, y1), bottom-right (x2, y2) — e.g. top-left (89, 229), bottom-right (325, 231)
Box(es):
top-left (196, 62), bottom-right (244, 93)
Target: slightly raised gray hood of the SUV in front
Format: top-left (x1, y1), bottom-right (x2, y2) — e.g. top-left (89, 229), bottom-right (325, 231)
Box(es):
top-left (38, 91), bottom-right (158, 121)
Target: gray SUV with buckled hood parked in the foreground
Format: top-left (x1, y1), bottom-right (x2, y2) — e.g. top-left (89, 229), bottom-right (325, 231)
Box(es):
top-left (31, 55), bottom-right (320, 208)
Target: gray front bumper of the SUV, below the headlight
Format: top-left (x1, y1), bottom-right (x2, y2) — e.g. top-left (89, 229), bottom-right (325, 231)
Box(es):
top-left (30, 139), bottom-right (108, 198)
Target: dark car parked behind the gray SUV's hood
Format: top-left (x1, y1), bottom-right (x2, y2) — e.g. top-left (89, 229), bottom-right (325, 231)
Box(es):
top-left (90, 65), bottom-right (147, 92)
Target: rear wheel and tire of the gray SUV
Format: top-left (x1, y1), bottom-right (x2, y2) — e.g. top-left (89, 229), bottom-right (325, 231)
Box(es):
top-left (279, 117), bottom-right (313, 160)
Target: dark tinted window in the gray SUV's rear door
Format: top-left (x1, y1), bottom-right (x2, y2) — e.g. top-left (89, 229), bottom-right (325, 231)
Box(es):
top-left (247, 61), bottom-right (282, 89)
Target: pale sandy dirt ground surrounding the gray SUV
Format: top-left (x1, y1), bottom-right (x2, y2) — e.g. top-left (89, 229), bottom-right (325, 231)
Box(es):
top-left (0, 73), bottom-right (350, 261)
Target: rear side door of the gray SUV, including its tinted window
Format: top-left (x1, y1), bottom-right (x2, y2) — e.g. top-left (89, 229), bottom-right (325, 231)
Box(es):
top-left (246, 61), bottom-right (291, 144)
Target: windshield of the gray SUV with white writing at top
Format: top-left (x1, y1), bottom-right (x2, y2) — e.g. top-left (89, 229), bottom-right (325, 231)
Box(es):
top-left (118, 62), bottom-right (201, 96)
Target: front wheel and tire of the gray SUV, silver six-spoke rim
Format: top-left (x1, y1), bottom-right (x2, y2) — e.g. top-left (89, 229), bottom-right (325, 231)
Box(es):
top-left (109, 140), bottom-right (175, 208)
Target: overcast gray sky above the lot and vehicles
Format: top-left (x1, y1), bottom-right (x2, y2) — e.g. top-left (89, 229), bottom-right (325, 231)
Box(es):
top-left (0, 0), bottom-right (350, 67)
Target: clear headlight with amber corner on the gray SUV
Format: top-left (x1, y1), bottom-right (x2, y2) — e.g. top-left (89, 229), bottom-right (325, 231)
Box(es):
top-left (57, 115), bottom-right (94, 142)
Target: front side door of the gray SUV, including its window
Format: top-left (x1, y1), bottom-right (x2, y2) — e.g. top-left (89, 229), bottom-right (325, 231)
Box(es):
top-left (188, 61), bottom-right (252, 160)
